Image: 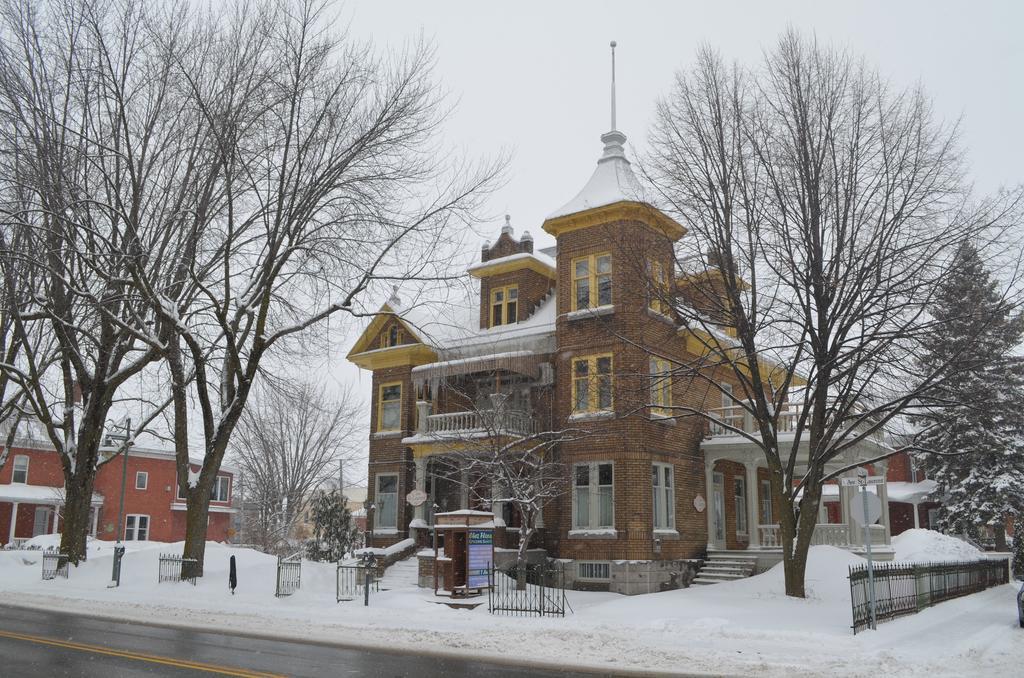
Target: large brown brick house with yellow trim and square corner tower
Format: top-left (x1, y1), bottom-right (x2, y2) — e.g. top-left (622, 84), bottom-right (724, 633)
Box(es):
top-left (347, 122), bottom-right (890, 593)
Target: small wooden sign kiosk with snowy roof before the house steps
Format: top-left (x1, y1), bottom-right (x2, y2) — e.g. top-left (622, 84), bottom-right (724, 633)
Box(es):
top-left (434, 509), bottom-right (495, 598)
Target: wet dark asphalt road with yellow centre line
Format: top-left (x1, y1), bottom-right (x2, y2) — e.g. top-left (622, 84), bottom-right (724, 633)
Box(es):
top-left (0, 605), bottom-right (610, 678)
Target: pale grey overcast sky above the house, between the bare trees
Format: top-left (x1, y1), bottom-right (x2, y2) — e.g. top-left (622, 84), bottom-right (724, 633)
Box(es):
top-left (330, 0), bottom-right (1024, 489)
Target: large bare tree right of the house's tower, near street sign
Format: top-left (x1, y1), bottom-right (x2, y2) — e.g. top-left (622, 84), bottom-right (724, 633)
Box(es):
top-left (646, 31), bottom-right (1020, 597)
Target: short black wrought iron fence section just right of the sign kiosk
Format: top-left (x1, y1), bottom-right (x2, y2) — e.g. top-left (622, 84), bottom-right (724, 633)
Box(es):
top-left (487, 563), bottom-right (572, 617)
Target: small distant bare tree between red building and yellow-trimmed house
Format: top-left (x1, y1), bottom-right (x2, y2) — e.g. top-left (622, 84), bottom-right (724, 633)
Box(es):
top-left (229, 380), bottom-right (360, 550)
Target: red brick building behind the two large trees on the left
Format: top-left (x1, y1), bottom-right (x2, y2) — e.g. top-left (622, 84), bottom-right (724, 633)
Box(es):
top-left (0, 436), bottom-right (236, 545)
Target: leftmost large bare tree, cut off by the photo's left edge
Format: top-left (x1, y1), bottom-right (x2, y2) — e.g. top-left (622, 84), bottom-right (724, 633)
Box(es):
top-left (0, 0), bottom-right (210, 563)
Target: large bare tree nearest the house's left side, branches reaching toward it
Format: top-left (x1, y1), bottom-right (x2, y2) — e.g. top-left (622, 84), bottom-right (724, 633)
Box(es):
top-left (141, 0), bottom-right (499, 574)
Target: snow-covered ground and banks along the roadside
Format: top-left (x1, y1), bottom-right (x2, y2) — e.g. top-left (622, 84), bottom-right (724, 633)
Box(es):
top-left (0, 531), bottom-right (1024, 677)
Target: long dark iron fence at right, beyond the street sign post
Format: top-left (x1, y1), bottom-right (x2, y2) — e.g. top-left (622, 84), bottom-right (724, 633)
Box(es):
top-left (850, 559), bottom-right (1010, 633)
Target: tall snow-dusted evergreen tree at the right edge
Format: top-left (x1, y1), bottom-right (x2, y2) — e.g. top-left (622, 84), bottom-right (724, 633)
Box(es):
top-left (919, 245), bottom-right (1024, 550)
